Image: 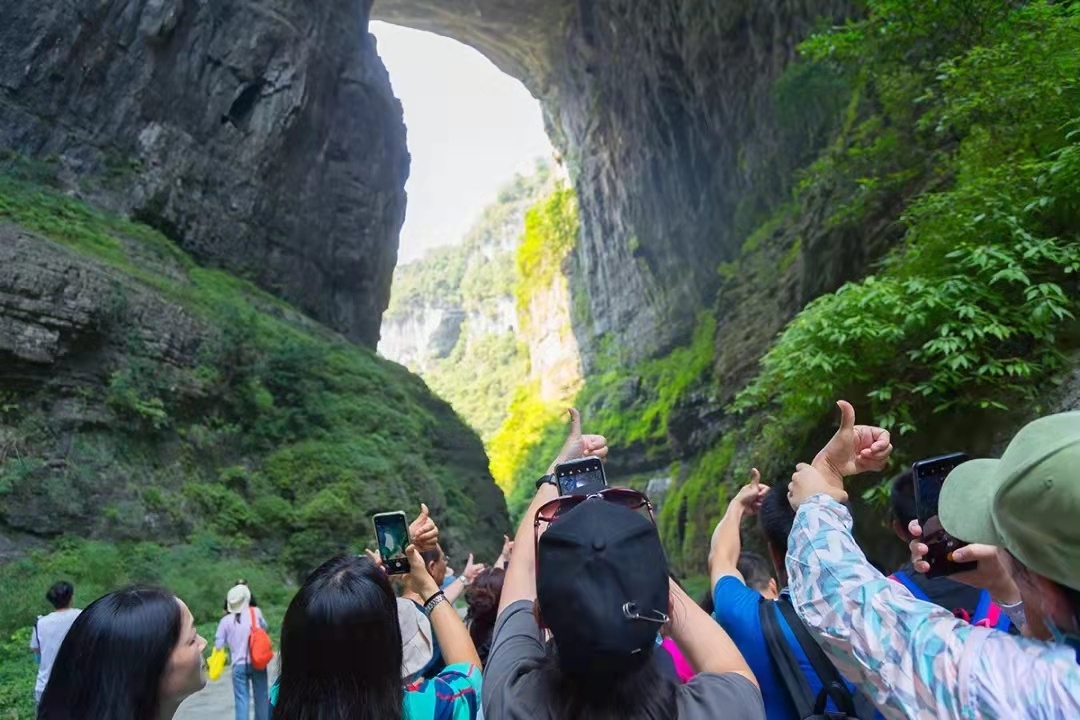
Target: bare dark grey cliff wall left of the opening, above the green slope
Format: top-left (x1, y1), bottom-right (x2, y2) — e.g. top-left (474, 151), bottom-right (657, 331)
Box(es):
top-left (0, 0), bottom-right (408, 347)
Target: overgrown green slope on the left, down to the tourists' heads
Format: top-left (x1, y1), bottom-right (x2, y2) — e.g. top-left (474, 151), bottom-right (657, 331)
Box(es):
top-left (0, 162), bottom-right (507, 708)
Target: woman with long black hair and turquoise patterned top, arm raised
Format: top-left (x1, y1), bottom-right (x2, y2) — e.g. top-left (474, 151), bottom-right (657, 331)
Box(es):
top-left (270, 518), bottom-right (481, 720)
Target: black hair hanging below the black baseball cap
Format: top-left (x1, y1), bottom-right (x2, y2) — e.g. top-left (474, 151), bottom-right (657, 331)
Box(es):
top-left (540, 652), bottom-right (678, 720)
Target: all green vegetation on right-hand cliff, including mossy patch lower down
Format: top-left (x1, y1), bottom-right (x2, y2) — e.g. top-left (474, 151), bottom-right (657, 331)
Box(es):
top-left (663, 0), bottom-right (1080, 568)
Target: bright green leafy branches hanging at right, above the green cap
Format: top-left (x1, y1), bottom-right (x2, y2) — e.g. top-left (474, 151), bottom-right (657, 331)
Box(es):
top-left (735, 3), bottom-right (1080, 451)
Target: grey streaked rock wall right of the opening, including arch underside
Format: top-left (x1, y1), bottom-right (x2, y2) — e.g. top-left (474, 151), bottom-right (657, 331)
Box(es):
top-left (374, 0), bottom-right (851, 360)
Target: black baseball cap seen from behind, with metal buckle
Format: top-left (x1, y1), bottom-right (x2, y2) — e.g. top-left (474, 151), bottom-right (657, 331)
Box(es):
top-left (537, 499), bottom-right (670, 675)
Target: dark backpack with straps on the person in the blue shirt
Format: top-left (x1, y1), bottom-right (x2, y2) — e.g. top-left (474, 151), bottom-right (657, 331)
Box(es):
top-left (758, 598), bottom-right (876, 720)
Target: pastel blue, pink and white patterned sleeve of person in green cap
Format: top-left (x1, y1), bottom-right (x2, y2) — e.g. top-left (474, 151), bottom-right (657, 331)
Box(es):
top-left (787, 495), bottom-right (1080, 720)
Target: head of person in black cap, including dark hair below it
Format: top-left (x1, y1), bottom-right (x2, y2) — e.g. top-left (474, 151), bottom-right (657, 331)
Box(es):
top-left (537, 500), bottom-right (675, 718)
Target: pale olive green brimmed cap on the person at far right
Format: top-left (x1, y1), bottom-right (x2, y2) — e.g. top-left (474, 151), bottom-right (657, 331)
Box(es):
top-left (937, 411), bottom-right (1080, 589)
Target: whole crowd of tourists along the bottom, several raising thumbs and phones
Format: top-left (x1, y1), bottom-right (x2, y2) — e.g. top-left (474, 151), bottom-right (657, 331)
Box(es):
top-left (23, 400), bottom-right (1080, 720)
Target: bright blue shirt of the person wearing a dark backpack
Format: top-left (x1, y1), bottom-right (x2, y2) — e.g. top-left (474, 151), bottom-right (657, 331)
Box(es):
top-left (713, 575), bottom-right (880, 720)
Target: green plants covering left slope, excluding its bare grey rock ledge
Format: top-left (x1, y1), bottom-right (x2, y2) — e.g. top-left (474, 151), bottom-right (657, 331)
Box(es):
top-left (0, 176), bottom-right (502, 589)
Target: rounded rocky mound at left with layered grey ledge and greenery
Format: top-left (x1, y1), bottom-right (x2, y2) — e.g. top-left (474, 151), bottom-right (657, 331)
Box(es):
top-left (0, 216), bottom-right (507, 573)
